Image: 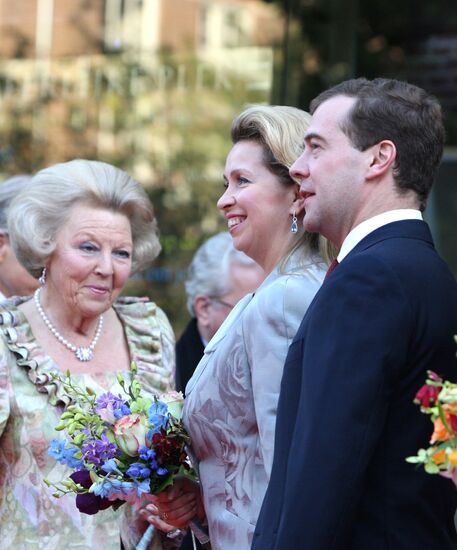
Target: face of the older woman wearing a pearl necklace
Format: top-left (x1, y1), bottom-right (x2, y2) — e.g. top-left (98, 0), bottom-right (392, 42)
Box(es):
top-left (46, 204), bottom-right (133, 317)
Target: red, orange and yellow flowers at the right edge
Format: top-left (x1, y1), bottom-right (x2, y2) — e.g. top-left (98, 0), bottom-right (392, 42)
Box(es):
top-left (406, 364), bottom-right (457, 487)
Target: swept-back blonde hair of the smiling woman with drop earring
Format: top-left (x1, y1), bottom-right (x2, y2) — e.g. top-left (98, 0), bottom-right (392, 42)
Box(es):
top-left (231, 105), bottom-right (335, 265)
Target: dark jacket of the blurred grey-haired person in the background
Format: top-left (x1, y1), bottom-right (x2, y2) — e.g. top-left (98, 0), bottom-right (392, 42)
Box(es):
top-left (176, 318), bottom-right (205, 393)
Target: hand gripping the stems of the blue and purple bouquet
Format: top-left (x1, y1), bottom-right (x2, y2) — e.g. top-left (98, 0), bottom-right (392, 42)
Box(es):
top-left (141, 478), bottom-right (205, 533)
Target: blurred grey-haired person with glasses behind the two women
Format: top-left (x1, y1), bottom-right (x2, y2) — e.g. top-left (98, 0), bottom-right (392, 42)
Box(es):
top-left (176, 232), bottom-right (264, 392)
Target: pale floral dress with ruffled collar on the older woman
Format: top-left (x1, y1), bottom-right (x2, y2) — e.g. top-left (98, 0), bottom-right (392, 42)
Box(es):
top-left (0, 298), bottom-right (175, 550)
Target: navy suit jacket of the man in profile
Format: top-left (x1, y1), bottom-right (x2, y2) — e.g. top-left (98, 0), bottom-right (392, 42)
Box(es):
top-left (252, 220), bottom-right (457, 550)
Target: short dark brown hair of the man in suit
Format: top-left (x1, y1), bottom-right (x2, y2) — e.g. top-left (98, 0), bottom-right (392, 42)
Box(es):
top-left (310, 78), bottom-right (445, 209)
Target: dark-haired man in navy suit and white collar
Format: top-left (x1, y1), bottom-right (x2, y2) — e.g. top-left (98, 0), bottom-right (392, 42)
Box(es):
top-left (252, 79), bottom-right (457, 550)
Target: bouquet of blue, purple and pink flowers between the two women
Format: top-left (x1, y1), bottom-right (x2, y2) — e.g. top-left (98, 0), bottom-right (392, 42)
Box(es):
top-left (46, 363), bottom-right (195, 514)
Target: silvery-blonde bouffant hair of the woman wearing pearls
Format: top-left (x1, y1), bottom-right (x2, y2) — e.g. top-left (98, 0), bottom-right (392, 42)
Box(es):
top-left (8, 159), bottom-right (160, 276)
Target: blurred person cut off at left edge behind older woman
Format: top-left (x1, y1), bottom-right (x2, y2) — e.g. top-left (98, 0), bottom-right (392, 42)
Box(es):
top-left (0, 175), bottom-right (38, 303)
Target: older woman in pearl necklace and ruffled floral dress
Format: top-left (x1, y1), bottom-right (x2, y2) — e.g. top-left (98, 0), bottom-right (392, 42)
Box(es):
top-left (0, 160), bottom-right (174, 549)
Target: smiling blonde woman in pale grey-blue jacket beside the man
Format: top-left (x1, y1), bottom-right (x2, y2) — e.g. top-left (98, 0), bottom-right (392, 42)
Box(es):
top-left (148, 106), bottom-right (334, 550)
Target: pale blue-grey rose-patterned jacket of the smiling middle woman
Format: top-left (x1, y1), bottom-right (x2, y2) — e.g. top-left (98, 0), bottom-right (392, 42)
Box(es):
top-left (183, 256), bottom-right (326, 550)
